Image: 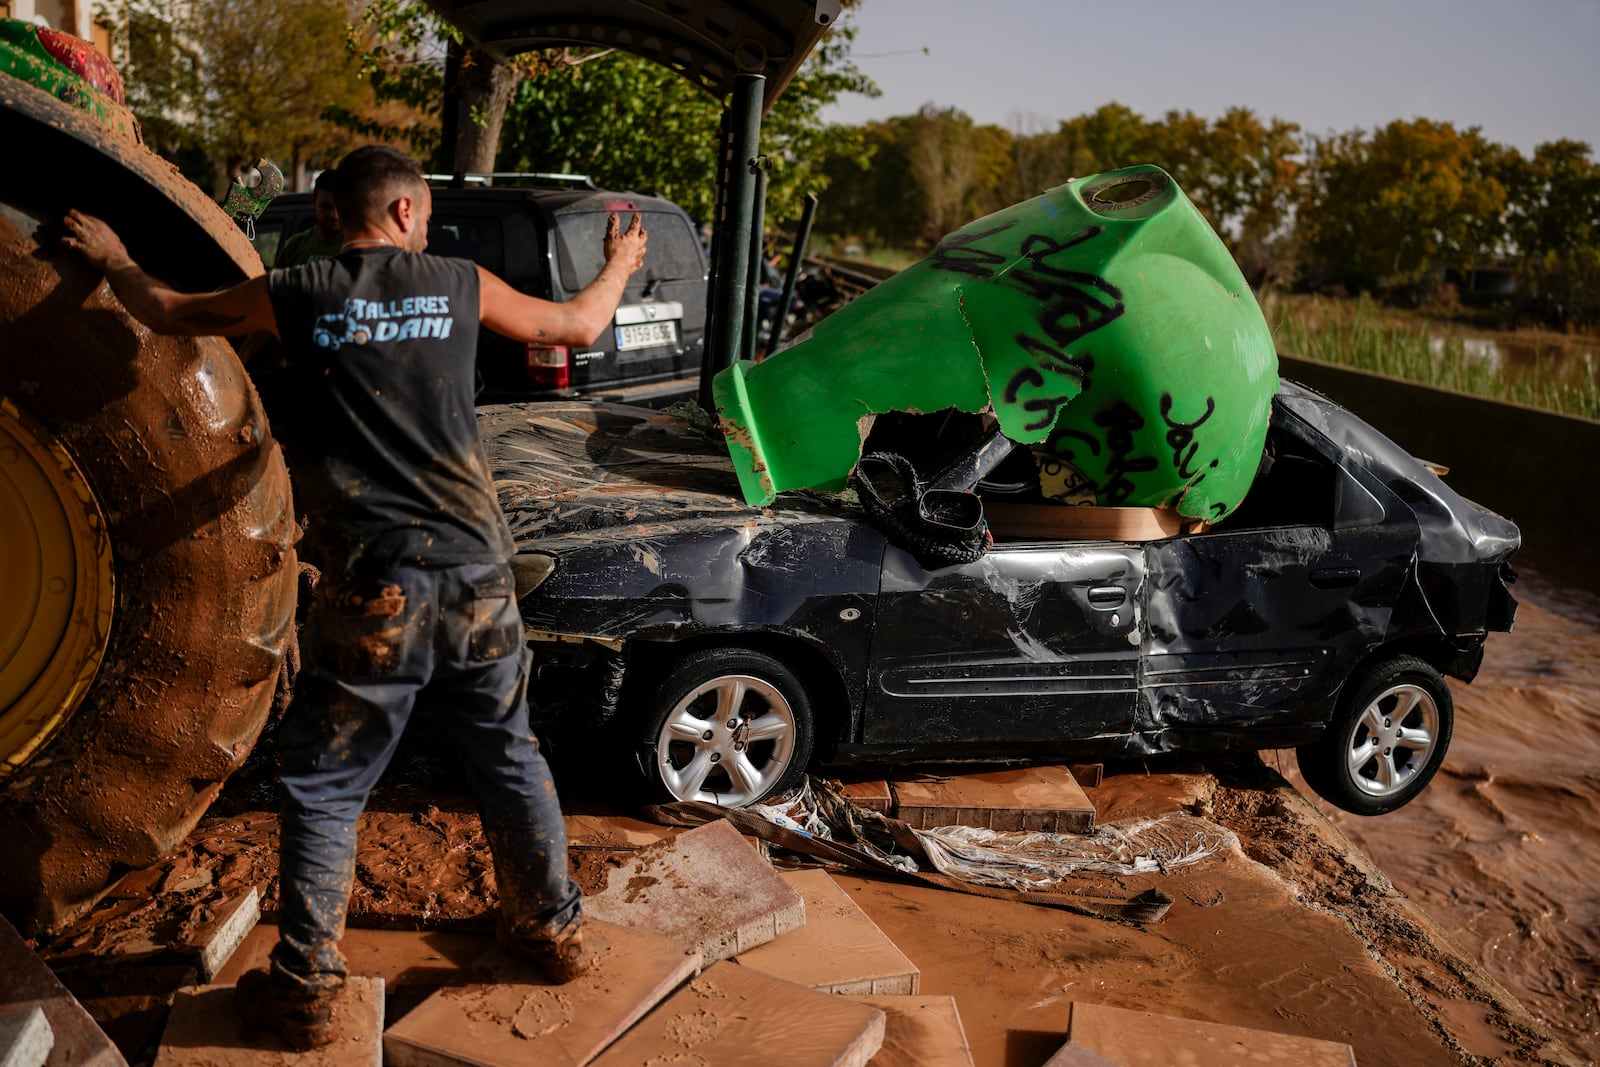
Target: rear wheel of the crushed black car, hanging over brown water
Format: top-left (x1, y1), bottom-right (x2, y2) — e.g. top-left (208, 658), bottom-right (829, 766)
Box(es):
top-left (1294, 656), bottom-right (1456, 816)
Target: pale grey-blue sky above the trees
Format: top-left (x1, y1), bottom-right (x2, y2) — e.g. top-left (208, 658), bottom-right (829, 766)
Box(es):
top-left (826, 0), bottom-right (1600, 155)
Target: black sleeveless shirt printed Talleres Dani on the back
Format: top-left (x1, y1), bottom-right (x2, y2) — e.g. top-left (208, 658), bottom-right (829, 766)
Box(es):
top-left (267, 248), bottom-right (510, 574)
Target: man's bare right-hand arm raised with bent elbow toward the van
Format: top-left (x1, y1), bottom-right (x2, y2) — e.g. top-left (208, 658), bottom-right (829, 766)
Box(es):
top-left (478, 207), bottom-right (650, 346)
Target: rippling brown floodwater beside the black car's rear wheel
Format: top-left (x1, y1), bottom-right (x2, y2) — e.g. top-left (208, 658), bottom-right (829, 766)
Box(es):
top-left (1280, 573), bottom-right (1600, 1062)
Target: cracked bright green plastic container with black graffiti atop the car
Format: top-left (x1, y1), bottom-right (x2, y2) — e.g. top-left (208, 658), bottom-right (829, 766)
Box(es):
top-left (715, 166), bottom-right (1278, 520)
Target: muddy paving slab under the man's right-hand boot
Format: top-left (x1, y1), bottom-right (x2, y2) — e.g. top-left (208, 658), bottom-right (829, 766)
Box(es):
top-left (384, 918), bottom-right (699, 1067)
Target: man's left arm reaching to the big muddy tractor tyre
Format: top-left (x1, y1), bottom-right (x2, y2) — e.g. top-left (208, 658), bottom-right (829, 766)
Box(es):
top-left (61, 211), bottom-right (278, 338)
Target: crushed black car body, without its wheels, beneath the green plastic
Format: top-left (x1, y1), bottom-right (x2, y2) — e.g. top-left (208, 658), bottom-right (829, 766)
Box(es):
top-left (480, 386), bottom-right (1518, 760)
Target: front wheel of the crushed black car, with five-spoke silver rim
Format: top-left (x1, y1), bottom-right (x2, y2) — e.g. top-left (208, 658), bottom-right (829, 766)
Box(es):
top-left (640, 648), bottom-right (814, 806)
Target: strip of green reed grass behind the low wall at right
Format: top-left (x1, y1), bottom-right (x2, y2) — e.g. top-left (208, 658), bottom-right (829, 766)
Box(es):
top-left (1262, 294), bottom-right (1600, 419)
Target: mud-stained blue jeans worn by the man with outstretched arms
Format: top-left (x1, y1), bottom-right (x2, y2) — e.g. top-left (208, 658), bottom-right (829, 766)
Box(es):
top-left (272, 563), bottom-right (579, 990)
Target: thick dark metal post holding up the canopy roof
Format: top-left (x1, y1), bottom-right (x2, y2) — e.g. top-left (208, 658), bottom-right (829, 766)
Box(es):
top-left (701, 74), bottom-right (766, 410)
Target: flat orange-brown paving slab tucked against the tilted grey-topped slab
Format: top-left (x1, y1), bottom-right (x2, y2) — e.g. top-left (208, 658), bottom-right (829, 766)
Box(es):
top-left (734, 870), bottom-right (920, 993)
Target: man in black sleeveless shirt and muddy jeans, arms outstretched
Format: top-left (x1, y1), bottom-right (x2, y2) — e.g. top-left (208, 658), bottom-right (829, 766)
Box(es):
top-left (64, 147), bottom-right (646, 1049)
